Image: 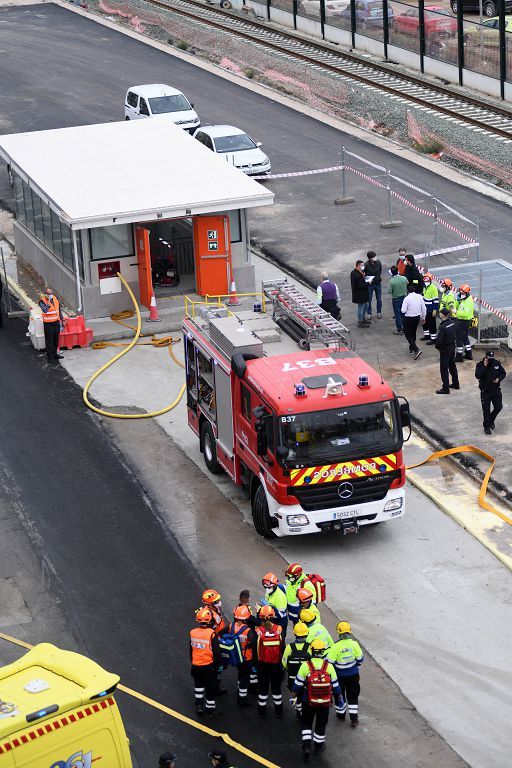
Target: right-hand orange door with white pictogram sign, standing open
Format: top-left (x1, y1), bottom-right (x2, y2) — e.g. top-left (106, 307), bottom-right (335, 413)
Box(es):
top-left (194, 216), bottom-right (232, 296)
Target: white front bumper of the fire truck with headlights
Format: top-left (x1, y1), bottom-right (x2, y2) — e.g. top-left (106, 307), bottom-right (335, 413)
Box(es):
top-left (265, 487), bottom-right (405, 536)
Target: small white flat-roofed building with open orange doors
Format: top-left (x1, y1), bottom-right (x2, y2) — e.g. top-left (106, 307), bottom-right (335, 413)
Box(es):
top-left (0, 117), bottom-right (274, 318)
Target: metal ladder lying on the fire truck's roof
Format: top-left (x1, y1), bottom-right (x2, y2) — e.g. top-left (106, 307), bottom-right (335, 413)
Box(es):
top-left (261, 278), bottom-right (353, 349)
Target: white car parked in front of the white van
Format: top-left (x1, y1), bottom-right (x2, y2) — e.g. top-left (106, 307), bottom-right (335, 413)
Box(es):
top-left (194, 125), bottom-right (272, 176)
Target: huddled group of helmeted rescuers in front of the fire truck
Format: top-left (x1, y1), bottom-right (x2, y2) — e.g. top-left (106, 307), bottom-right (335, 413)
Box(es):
top-left (190, 563), bottom-right (363, 761)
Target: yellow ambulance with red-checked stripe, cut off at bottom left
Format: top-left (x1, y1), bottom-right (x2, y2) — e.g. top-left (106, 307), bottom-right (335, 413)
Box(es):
top-left (0, 643), bottom-right (132, 768)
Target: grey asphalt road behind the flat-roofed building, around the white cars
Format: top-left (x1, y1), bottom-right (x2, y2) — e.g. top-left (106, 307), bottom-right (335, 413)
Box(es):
top-left (0, 0), bottom-right (511, 284)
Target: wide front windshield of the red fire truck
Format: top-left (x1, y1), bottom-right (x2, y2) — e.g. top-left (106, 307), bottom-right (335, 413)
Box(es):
top-left (279, 400), bottom-right (401, 466)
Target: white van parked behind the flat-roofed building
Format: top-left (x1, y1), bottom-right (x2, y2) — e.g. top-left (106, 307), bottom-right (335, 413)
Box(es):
top-left (124, 83), bottom-right (201, 133)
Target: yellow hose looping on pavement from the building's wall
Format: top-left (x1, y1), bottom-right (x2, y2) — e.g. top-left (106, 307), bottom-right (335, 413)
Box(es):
top-left (83, 272), bottom-right (185, 419)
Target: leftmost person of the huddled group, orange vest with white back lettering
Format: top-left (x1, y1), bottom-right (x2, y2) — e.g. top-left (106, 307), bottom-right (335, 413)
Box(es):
top-left (190, 608), bottom-right (222, 716)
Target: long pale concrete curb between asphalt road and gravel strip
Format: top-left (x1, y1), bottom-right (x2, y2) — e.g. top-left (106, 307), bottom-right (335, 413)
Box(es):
top-left (51, 0), bottom-right (512, 207)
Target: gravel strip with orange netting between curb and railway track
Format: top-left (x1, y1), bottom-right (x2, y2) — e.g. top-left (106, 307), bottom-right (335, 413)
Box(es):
top-left (88, 0), bottom-right (512, 191)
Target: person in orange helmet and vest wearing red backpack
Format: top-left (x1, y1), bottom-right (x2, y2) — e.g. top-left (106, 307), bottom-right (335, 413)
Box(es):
top-left (256, 605), bottom-right (284, 718)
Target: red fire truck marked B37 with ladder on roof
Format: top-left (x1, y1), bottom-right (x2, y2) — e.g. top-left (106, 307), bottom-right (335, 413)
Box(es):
top-left (183, 281), bottom-right (410, 536)
